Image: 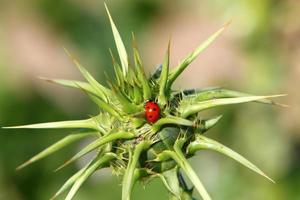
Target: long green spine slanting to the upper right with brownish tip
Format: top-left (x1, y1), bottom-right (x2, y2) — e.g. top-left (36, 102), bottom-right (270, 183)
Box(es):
top-left (169, 23), bottom-right (229, 88)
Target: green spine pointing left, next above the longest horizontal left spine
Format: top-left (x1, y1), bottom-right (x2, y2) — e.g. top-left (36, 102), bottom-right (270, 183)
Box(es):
top-left (39, 77), bottom-right (97, 95)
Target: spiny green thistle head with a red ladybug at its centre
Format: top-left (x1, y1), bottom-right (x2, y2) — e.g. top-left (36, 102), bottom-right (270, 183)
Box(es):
top-left (5, 4), bottom-right (283, 200)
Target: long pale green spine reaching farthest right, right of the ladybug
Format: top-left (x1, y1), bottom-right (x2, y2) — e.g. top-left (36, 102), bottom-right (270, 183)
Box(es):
top-left (178, 94), bottom-right (286, 118)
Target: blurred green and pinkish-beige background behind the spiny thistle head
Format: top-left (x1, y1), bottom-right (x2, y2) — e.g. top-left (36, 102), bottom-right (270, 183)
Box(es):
top-left (0, 0), bottom-right (300, 200)
